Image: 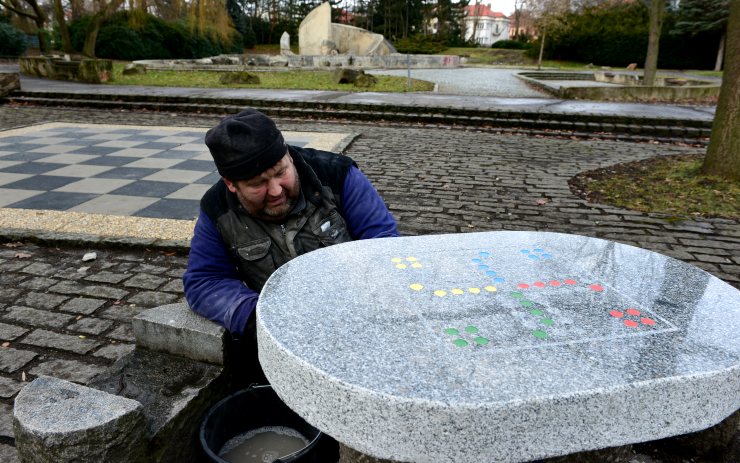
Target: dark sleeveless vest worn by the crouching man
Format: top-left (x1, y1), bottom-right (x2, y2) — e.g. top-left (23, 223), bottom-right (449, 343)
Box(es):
top-left (201, 146), bottom-right (354, 291)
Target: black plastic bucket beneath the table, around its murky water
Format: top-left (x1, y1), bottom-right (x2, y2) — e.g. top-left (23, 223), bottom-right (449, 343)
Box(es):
top-left (200, 385), bottom-right (325, 463)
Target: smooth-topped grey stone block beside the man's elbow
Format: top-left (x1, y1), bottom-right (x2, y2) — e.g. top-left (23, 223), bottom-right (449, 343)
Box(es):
top-left (133, 303), bottom-right (226, 365)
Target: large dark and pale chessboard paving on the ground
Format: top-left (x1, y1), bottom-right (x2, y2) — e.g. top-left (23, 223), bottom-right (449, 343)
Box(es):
top-left (0, 123), bottom-right (347, 220)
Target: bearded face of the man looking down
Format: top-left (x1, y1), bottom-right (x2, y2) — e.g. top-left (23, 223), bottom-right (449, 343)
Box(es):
top-left (224, 154), bottom-right (301, 221)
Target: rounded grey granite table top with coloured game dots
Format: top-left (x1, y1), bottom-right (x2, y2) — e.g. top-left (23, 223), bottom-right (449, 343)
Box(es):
top-left (257, 232), bottom-right (740, 463)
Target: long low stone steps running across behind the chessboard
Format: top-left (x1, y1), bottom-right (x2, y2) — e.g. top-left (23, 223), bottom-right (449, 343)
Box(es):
top-left (0, 91), bottom-right (711, 144)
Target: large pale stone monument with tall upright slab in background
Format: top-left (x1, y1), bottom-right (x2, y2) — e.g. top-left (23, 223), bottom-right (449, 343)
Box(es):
top-left (298, 2), bottom-right (396, 56)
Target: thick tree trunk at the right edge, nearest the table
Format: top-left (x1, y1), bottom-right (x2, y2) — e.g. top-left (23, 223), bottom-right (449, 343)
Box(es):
top-left (702, 0), bottom-right (740, 181)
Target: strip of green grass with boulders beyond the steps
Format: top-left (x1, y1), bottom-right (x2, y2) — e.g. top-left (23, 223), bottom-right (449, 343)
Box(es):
top-left (110, 62), bottom-right (434, 93)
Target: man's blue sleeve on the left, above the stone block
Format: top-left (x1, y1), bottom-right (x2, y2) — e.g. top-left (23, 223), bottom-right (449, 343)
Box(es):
top-left (182, 211), bottom-right (259, 336)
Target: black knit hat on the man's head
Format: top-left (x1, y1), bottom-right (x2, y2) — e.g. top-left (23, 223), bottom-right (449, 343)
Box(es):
top-left (206, 109), bottom-right (288, 180)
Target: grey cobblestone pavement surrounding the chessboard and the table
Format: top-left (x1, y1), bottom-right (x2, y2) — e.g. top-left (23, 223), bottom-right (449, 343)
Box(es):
top-left (0, 106), bottom-right (740, 462)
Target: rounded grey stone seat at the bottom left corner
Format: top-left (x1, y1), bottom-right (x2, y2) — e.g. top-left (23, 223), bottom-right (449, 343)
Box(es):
top-left (13, 376), bottom-right (146, 463)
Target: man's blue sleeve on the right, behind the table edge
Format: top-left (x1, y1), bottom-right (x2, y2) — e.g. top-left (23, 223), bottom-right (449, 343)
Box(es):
top-left (340, 166), bottom-right (399, 240)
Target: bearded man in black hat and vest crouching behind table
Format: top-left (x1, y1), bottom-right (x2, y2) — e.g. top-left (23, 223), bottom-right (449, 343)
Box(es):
top-left (183, 109), bottom-right (398, 380)
